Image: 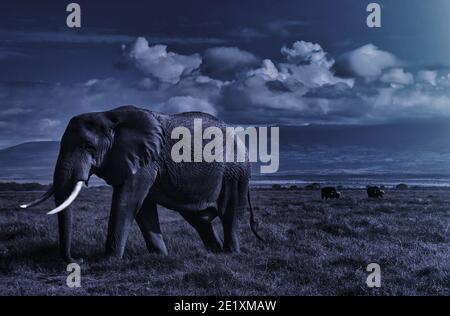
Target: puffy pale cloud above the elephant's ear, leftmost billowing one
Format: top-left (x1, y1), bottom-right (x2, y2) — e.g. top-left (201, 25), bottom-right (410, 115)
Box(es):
top-left (128, 37), bottom-right (202, 84)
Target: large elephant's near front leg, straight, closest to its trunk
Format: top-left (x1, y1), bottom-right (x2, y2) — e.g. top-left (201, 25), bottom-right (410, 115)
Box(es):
top-left (106, 175), bottom-right (153, 258)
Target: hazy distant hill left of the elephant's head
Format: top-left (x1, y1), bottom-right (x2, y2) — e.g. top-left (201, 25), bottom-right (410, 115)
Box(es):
top-left (0, 141), bottom-right (59, 181)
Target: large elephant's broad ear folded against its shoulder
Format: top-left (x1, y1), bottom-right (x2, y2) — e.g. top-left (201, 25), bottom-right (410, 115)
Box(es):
top-left (108, 106), bottom-right (164, 185)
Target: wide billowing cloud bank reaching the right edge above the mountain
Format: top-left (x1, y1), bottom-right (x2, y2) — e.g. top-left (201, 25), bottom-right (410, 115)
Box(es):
top-left (215, 41), bottom-right (450, 124)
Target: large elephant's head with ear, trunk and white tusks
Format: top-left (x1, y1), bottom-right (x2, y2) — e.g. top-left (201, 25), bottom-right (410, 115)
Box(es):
top-left (21, 106), bottom-right (163, 262)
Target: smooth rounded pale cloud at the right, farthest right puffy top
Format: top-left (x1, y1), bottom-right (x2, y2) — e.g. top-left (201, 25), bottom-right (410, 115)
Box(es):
top-left (338, 44), bottom-right (399, 81)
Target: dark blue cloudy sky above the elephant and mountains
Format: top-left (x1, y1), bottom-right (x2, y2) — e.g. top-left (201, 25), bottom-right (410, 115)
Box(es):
top-left (0, 0), bottom-right (450, 148)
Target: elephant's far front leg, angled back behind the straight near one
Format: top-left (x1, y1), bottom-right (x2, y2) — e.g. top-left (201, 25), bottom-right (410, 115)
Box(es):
top-left (136, 198), bottom-right (168, 255)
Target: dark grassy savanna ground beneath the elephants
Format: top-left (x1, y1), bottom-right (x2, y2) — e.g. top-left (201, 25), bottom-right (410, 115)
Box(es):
top-left (0, 188), bottom-right (450, 295)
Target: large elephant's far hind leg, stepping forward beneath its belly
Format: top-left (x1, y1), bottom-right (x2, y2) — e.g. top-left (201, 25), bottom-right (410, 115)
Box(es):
top-left (180, 209), bottom-right (222, 252)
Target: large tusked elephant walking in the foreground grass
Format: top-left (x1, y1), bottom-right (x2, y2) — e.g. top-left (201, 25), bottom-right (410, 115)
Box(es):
top-left (21, 106), bottom-right (262, 262)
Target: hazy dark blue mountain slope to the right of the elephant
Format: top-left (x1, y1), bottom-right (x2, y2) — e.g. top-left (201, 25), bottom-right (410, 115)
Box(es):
top-left (272, 120), bottom-right (450, 176)
